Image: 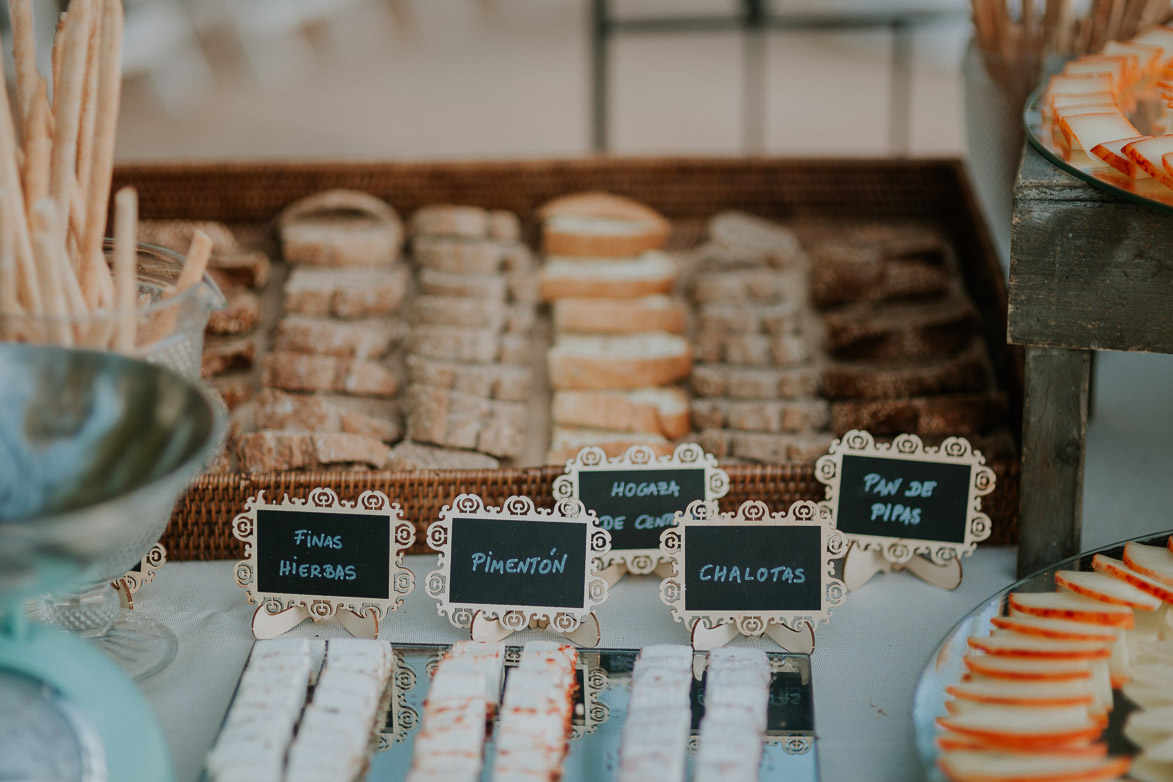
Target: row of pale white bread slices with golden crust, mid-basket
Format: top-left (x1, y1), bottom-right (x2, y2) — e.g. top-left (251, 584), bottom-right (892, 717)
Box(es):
top-left (538, 192), bottom-right (692, 463)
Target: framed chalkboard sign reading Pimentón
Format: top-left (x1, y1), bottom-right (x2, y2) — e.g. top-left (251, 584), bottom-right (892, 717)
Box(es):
top-left (427, 495), bottom-right (610, 633)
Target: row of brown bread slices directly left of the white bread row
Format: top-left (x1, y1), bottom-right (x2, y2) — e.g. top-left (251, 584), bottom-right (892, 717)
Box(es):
top-left (404, 204), bottom-right (537, 468)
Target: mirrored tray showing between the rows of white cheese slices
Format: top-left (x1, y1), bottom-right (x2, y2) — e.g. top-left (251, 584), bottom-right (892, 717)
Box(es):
top-left (206, 644), bottom-right (819, 782)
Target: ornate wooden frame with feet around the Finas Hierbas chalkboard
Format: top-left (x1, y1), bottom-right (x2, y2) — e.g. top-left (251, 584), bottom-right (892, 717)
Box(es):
top-left (232, 488), bottom-right (415, 638)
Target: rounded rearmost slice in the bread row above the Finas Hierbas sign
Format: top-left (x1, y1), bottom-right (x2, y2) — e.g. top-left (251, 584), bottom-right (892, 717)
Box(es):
top-left (277, 190), bottom-right (404, 268)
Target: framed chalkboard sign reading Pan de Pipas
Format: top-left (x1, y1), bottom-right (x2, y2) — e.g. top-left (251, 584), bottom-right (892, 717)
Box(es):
top-left (815, 430), bottom-right (994, 560)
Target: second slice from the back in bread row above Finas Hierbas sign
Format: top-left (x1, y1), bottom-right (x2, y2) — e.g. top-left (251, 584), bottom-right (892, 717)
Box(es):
top-left (285, 264), bottom-right (412, 318)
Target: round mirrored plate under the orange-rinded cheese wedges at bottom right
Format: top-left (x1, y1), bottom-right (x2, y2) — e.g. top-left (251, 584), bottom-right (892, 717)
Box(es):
top-left (913, 530), bottom-right (1173, 782)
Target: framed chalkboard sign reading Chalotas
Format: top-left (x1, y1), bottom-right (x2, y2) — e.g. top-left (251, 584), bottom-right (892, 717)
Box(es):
top-left (660, 501), bottom-right (846, 635)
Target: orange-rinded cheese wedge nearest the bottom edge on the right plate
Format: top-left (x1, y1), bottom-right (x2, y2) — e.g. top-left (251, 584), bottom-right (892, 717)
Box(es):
top-left (937, 750), bottom-right (1131, 782)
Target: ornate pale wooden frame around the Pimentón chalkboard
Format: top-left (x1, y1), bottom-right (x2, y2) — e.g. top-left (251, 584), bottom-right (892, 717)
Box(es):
top-left (425, 494), bottom-right (611, 642)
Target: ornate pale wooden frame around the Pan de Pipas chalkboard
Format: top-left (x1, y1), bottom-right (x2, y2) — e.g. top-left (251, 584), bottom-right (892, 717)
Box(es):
top-left (814, 429), bottom-right (995, 569)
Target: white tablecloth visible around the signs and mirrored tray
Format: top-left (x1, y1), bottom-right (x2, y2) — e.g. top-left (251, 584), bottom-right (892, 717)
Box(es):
top-left (136, 548), bottom-right (1015, 782)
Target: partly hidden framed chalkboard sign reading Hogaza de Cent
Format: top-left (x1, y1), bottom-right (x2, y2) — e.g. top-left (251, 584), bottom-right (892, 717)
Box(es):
top-left (554, 443), bottom-right (728, 573)
